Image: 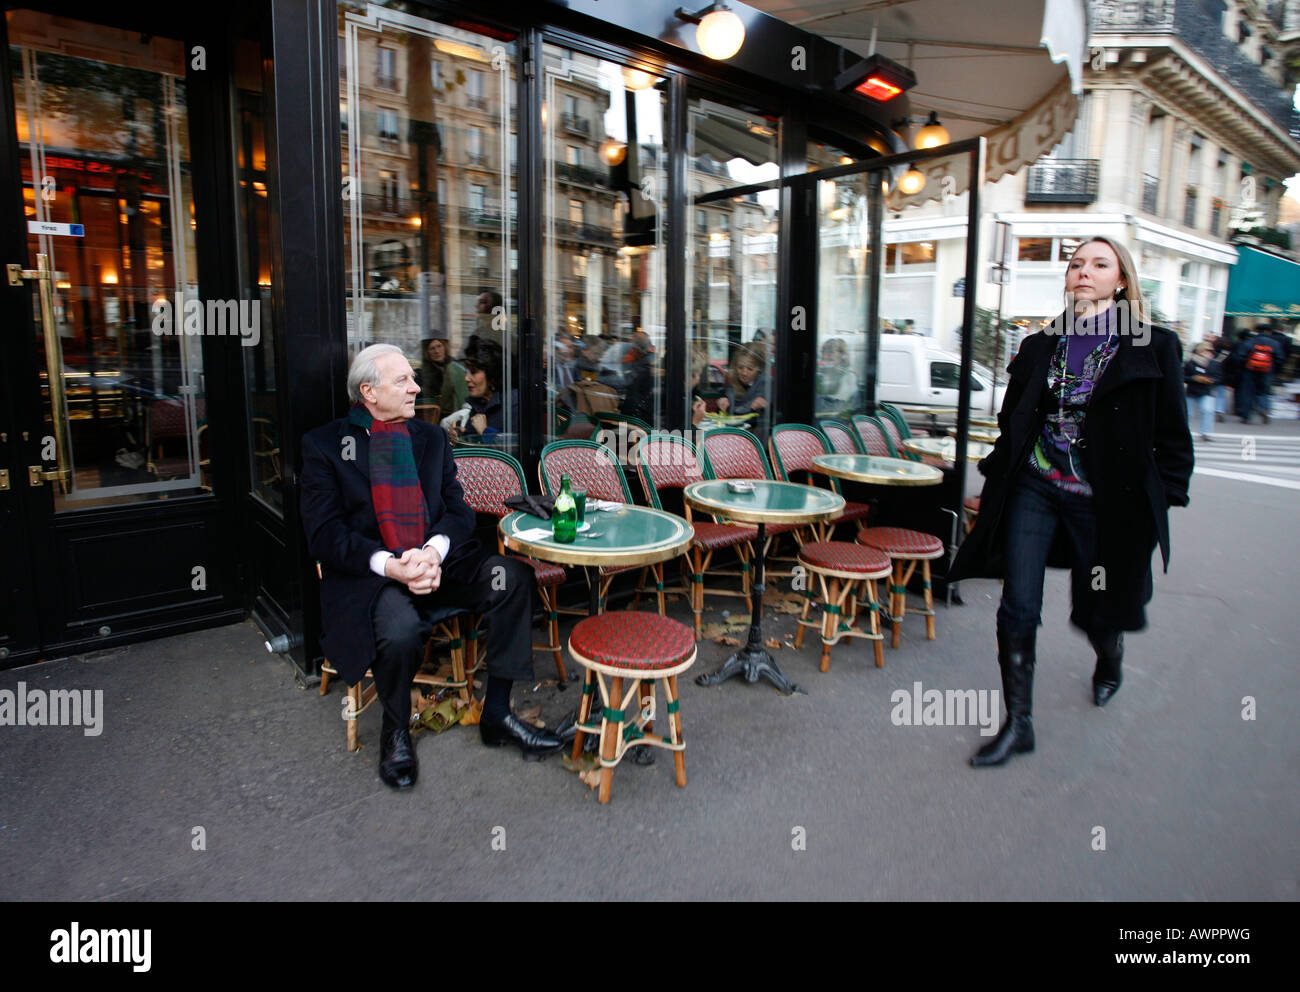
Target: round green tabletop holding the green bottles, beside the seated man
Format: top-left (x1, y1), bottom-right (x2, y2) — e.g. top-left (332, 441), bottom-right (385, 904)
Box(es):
top-left (499, 504), bottom-right (696, 566)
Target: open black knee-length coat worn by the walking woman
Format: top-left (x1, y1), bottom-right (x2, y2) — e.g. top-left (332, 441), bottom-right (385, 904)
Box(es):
top-left (949, 326), bottom-right (1192, 631)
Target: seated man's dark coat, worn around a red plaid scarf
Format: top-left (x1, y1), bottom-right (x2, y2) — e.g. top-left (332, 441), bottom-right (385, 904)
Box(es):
top-left (299, 417), bottom-right (478, 685)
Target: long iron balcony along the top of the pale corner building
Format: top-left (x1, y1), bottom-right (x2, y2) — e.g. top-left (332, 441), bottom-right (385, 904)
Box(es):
top-left (1092, 0), bottom-right (1300, 140)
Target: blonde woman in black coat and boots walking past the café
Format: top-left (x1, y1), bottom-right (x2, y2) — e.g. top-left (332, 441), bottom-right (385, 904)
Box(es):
top-left (949, 238), bottom-right (1192, 766)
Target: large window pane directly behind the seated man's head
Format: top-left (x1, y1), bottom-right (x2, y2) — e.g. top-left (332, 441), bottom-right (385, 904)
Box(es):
top-left (338, 0), bottom-right (519, 447)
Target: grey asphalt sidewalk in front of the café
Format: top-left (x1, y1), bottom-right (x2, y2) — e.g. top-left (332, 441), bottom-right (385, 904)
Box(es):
top-left (0, 424), bottom-right (1300, 901)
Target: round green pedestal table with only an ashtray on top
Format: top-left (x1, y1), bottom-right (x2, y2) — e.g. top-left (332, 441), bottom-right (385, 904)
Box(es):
top-left (683, 478), bottom-right (844, 693)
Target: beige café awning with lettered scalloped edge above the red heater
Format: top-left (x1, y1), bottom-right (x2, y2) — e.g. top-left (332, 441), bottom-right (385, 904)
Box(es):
top-left (748, 0), bottom-right (1088, 187)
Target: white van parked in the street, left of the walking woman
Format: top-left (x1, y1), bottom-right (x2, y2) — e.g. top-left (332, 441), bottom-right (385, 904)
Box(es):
top-left (876, 334), bottom-right (1006, 416)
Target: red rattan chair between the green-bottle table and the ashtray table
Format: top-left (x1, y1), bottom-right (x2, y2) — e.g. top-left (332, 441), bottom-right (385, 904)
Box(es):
top-left (633, 432), bottom-right (758, 640)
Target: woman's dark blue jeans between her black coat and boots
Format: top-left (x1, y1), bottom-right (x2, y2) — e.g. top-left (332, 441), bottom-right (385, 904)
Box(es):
top-left (997, 468), bottom-right (1099, 636)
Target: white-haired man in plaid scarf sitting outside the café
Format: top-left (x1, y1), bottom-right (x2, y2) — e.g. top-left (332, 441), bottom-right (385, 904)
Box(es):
top-left (300, 345), bottom-right (563, 789)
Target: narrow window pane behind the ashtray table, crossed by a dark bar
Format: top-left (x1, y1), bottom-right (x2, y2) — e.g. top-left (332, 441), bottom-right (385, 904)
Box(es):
top-left (686, 99), bottom-right (781, 441)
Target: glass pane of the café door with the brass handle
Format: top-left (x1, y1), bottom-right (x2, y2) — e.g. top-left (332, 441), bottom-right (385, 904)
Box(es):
top-left (9, 10), bottom-right (205, 510)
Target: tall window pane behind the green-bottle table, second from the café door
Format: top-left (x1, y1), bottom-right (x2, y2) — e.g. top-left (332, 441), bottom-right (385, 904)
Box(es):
top-left (542, 44), bottom-right (667, 437)
